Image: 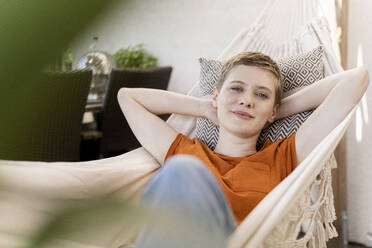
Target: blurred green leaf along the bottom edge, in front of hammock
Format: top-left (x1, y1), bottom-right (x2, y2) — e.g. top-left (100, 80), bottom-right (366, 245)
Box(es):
top-left (28, 197), bottom-right (223, 248)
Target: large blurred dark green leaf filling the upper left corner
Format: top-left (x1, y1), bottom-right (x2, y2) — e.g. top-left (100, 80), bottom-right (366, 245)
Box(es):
top-left (0, 0), bottom-right (114, 159)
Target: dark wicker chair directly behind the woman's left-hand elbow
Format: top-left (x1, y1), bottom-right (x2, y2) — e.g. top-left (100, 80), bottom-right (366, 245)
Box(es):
top-left (99, 66), bottom-right (172, 157)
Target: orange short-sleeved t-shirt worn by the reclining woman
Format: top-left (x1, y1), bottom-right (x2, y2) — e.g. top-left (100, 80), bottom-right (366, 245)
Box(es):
top-left (164, 133), bottom-right (297, 225)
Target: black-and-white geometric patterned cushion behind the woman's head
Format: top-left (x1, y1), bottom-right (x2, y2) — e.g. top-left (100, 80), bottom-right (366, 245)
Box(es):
top-left (196, 46), bottom-right (324, 150)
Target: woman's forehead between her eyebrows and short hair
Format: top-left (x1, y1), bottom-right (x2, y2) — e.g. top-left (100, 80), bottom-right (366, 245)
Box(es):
top-left (224, 65), bottom-right (276, 91)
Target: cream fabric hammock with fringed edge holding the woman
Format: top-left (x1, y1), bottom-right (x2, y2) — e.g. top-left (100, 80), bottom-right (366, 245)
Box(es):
top-left (0, 0), bottom-right (355, 248)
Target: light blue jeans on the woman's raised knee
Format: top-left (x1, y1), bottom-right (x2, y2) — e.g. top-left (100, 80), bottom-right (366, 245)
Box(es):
top-left (136, 155), bottom-right (236, 248)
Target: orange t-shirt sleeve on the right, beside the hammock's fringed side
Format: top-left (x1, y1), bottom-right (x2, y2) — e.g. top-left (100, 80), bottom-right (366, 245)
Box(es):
top-left (277, 133), bottom-right (297, 176)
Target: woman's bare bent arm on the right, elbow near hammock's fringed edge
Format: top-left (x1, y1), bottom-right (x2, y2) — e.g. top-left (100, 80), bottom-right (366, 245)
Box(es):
top-left (278, 67), bottom-right (370, 163)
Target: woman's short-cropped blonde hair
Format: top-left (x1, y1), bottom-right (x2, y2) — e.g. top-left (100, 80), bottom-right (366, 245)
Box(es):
top-left (216, 52), bottom-right (283, 104)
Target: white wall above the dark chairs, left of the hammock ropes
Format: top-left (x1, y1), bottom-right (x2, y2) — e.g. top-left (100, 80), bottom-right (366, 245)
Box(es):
top-left (72, 0), bottom-right (267, 93)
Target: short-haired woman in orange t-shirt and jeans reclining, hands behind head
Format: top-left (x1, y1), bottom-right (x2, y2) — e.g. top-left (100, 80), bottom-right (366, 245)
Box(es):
top-left (118, 52), bottom-right (369, 247)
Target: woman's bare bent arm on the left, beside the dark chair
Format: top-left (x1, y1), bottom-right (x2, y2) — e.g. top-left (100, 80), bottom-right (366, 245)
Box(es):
top-left (118, 88), bottom-right (208, 164)
